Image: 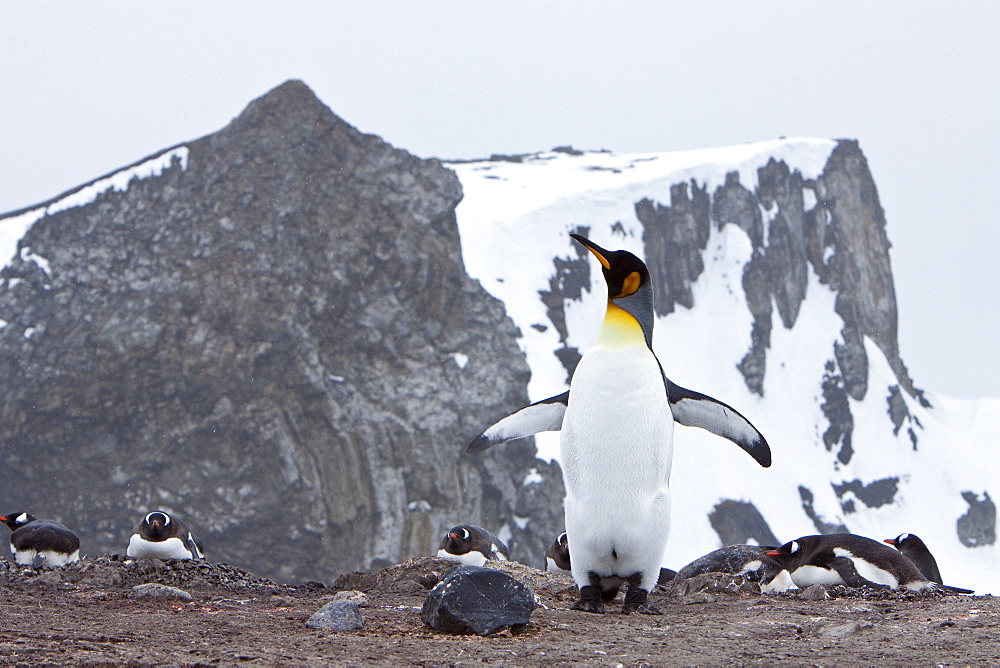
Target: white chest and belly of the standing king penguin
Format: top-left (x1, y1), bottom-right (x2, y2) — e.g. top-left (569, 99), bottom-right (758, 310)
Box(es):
top-left (560, 346), bottom-right (674, 590)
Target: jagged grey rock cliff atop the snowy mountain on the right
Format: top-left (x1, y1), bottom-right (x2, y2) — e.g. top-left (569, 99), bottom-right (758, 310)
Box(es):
top-left (636, 140), bottom-right (925, 474)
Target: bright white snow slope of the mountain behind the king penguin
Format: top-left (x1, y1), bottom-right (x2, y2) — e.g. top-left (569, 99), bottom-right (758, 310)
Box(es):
top-left (449, 139), bottom-right (1000, 593)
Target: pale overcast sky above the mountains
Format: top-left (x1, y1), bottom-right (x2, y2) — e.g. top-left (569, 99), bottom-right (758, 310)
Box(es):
top-left (0, 0), bottom-right (1000, 397)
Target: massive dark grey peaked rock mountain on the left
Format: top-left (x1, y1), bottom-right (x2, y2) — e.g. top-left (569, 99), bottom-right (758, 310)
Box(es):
top-left (0, 82), bottom-right (563, 580)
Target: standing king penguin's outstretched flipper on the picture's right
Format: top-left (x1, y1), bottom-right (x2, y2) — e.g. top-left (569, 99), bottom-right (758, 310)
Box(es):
top-left (661, 370), bottom-right (771, 468)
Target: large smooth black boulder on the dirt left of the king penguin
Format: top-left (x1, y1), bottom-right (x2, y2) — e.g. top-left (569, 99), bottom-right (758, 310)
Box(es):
top-left (420, 566), bottom-right (535, 636)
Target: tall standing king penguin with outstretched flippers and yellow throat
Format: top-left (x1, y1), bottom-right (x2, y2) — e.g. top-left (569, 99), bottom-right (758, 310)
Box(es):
top-left (468, 234), bottom-right (771, 614)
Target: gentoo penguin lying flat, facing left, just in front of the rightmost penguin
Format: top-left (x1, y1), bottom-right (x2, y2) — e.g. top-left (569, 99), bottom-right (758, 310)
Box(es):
top-left (767, 533), bottom-right (972, 594)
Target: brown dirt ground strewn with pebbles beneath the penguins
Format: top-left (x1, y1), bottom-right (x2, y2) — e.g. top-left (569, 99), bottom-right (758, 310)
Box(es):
top-left (0, 557), bottom-right (1000, 666)
